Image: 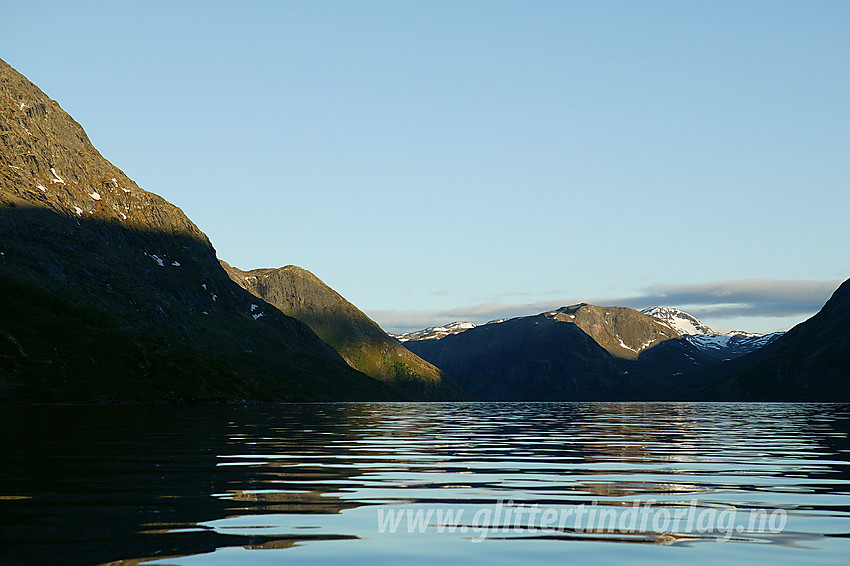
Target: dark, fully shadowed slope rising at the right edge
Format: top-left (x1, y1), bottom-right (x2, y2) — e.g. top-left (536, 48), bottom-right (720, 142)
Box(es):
top-left (701, 280), bottom-right (850, 402)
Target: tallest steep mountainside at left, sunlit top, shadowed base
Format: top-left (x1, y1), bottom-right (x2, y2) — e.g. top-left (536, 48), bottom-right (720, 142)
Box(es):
top-left (0, 57), bottom-right (401, 401)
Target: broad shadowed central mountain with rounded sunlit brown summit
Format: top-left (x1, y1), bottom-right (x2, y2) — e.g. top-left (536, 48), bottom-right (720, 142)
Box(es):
top-left (404, 304), bottom-right (710, 401)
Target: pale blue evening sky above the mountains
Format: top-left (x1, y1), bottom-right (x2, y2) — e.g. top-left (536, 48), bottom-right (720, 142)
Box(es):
top-left (0, 0), bottom-right (850, 332)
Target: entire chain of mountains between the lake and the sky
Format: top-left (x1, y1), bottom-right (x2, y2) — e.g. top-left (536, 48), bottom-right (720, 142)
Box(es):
top-left (0, 60), bottom-right (850, 403)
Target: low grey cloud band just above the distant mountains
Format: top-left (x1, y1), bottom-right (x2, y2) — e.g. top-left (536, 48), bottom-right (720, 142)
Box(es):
top-left (369, 279), bottom-right (841, 338)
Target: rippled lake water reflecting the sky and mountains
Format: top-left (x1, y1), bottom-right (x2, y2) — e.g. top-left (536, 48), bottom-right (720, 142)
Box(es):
top-left (0, 403), bottom-right (850, 566)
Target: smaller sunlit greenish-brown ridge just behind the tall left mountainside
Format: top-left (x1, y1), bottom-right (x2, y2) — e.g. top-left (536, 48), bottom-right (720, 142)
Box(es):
top-left (217, 262), bottom-right (463, 399)
